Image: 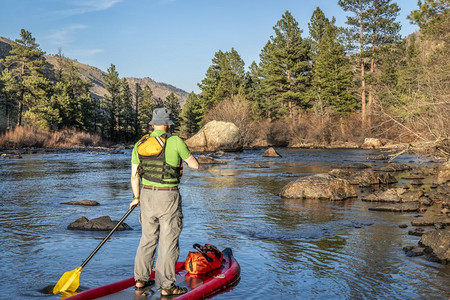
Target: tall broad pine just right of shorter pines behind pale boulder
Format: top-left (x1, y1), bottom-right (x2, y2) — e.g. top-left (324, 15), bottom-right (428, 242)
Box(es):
top-left (260, 11), bottom-right (311, 120)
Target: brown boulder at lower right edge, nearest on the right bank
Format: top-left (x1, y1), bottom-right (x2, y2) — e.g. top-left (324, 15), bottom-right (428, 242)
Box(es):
top-left (419, 228), bottom-right (450, 264)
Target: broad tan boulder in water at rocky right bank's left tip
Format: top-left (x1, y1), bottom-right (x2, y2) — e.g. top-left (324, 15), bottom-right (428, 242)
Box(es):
top-left (280, 174), bottom-right (356, 200)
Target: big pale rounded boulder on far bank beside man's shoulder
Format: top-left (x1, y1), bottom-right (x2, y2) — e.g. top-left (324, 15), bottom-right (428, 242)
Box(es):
top-left (186, 121), bottom-right (244, 152)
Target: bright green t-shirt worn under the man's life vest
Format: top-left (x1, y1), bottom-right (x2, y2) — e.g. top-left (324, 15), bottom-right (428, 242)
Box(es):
top-left (131, 130), bottom-right (191, 186)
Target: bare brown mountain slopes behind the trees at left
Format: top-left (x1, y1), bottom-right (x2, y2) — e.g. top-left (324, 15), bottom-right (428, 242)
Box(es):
top-left (0, 36), bottom-right (189, 106)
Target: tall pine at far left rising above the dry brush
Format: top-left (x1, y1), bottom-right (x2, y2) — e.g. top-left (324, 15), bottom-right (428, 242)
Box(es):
top-left (1, 29), bottom-right (54, 127)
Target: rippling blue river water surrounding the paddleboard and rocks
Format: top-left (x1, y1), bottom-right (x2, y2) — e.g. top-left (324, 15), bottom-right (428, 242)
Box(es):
top-left (0, 148), bottom-right (450, 299)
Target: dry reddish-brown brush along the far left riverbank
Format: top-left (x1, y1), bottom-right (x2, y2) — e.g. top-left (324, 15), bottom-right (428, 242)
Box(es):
top-left (0, 126), bottom-right (101, 149)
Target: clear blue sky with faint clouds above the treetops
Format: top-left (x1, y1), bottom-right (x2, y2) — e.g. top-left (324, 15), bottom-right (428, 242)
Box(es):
top-left (0, 0), bottom-right (417, 93)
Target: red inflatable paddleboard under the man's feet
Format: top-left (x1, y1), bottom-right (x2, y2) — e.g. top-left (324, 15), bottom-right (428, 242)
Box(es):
top-left (65, 248), bottom-right (241, 300)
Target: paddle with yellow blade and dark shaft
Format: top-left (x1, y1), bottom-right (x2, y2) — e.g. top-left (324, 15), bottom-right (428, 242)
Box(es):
top-left (53, 205), bottom-right (136, 294)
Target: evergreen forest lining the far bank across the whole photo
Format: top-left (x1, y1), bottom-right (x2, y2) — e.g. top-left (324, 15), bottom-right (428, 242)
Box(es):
top-left (0, 0), bottom-right (450, 151)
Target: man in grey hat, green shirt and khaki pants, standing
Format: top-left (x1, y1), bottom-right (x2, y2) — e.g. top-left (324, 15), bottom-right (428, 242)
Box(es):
top-left (130, 108), bottom-right (199, 296)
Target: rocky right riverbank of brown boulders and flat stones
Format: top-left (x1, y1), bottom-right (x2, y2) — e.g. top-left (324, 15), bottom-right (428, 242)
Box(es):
top-left (280, 162), bottom-right (450, 264)
